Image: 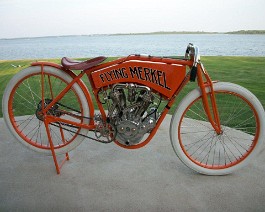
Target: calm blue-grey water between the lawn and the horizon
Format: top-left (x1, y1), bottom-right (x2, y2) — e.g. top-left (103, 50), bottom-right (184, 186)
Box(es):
top-left (0, 34), bottom-right (265, 60)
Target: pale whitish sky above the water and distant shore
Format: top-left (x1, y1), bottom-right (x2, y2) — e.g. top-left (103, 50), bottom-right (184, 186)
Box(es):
top-left (0, 0), bottom-right (265, 38)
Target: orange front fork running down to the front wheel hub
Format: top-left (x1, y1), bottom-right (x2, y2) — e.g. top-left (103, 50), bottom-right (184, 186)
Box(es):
top-left (197, 63), bottom-right (222, 135)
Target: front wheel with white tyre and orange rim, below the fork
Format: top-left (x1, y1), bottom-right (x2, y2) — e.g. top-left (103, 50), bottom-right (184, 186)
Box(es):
top-left (170, 83), bottom-right (265, 175)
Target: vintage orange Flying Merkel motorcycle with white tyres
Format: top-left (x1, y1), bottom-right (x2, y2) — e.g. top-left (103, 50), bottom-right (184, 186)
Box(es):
top-left (3, 44), bottom-right (265, 175)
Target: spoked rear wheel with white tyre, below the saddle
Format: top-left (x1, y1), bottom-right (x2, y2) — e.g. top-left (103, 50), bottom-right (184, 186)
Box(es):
top-left (3, 66), bottom-right (89, 154)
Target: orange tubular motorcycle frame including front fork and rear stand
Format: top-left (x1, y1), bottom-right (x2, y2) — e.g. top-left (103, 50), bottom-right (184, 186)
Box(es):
top-left (31, 55), bottom-right (222, 174)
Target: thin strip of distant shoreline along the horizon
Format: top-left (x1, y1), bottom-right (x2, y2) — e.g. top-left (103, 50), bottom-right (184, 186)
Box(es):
top-left (0, 30), bottom-right (265, 40)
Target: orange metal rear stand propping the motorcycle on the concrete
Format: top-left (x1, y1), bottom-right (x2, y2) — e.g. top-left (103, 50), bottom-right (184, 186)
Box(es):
top-left (44, 118), bottom-right (70, 174)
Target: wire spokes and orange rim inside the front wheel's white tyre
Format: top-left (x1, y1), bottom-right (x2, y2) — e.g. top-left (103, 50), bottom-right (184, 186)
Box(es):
top-left (179, 88), bottom-right (257, 169)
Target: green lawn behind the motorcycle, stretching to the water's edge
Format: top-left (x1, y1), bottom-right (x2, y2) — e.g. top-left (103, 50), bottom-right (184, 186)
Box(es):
top-left (0, 56), bottom-right (265, 117)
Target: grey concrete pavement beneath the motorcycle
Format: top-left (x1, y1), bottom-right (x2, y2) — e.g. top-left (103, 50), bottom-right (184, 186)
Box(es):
top-left (0, 116), bottom-right (265, 212)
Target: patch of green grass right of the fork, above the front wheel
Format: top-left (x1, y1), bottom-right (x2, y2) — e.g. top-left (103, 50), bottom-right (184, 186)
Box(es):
top-left (202, 57), bottom-right (265, 106)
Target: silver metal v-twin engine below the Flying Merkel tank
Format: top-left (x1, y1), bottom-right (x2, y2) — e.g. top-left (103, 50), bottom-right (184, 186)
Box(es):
top-left (104, 83), bottom-right (158, 145)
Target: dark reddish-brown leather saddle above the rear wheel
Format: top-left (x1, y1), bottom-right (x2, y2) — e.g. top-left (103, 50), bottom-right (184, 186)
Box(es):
top-left (61, 56), bottom-right (106, 70)
